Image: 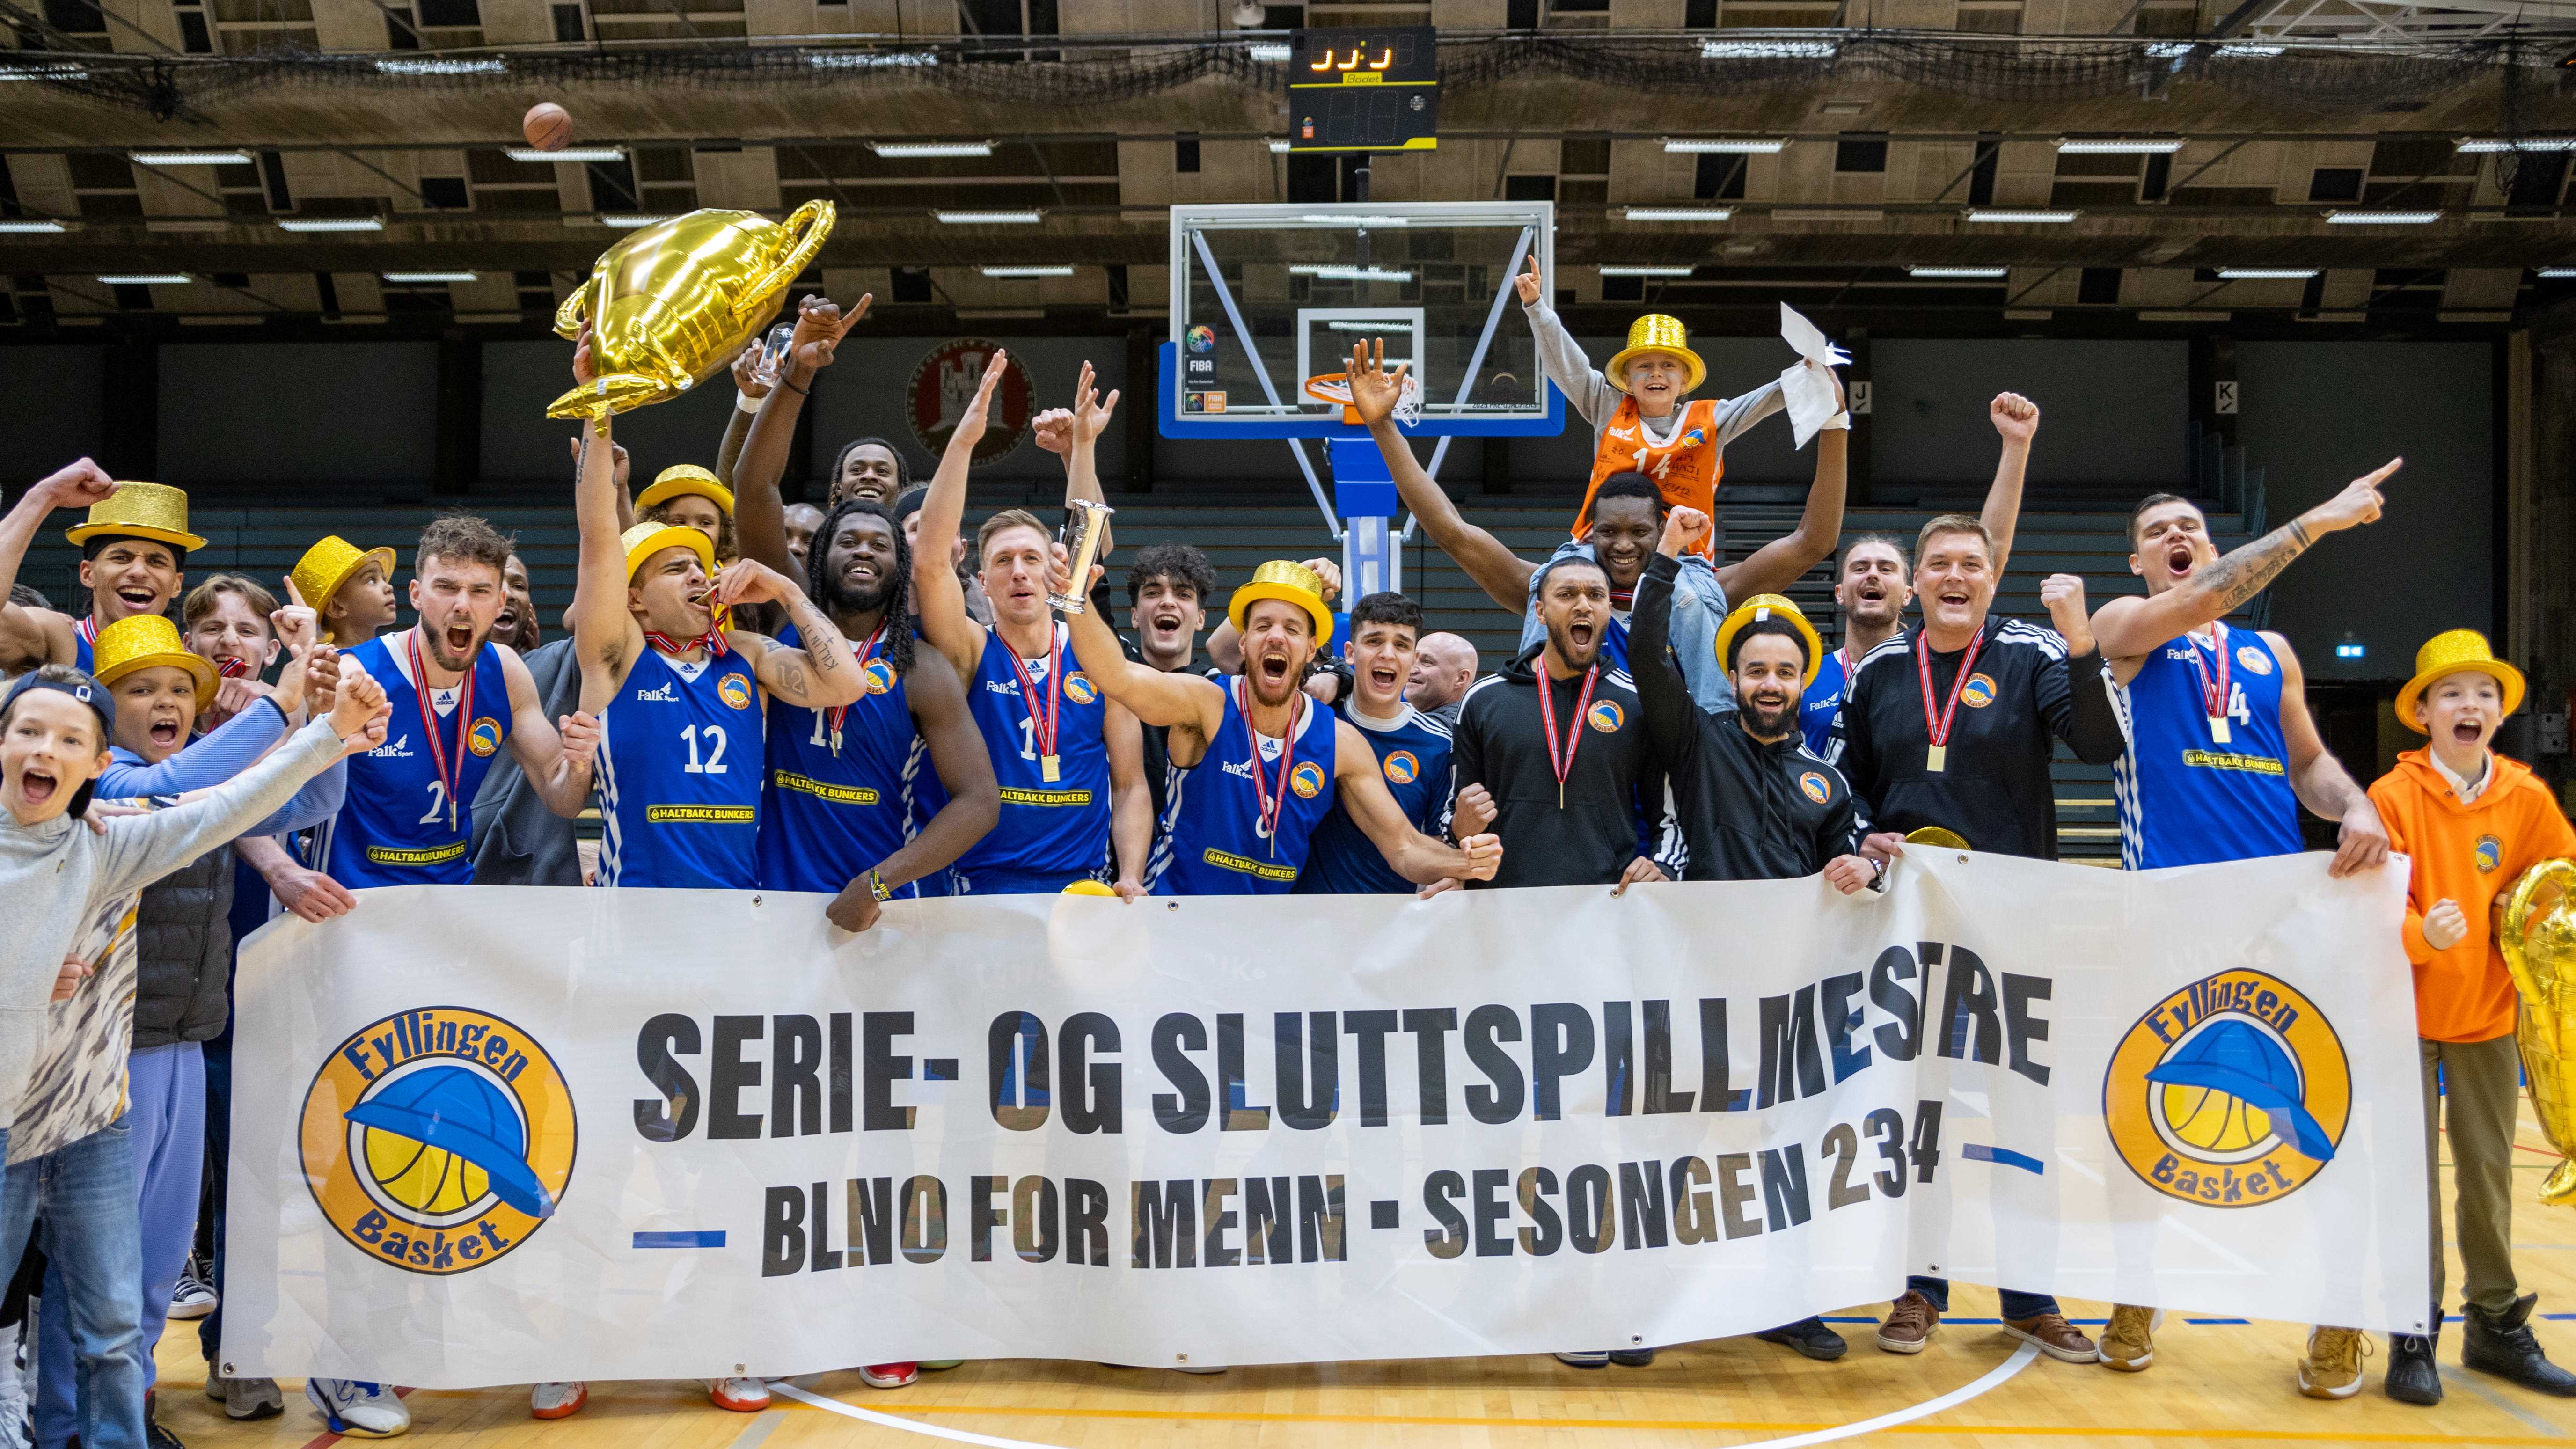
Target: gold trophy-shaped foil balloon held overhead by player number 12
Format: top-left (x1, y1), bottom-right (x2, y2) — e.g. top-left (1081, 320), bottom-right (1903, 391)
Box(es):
top-left (546, 201), bottom-right (832, 417)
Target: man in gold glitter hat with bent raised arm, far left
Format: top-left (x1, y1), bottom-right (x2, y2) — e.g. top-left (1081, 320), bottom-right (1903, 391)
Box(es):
top-left (0, 459), bottom-right (206, 670)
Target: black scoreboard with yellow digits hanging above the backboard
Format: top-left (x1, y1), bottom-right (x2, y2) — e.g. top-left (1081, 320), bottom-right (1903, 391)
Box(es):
top-left (1288, 26), bottom-right (1440, 152)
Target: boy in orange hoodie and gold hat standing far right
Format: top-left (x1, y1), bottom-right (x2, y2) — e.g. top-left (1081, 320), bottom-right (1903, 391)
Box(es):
top-left (2349, 629), bottom-right (2576, 1403)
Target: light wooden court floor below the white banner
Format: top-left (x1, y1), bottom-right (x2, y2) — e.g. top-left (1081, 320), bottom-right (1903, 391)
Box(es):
top-left (160, 1104), bottom-right (2576, 1449)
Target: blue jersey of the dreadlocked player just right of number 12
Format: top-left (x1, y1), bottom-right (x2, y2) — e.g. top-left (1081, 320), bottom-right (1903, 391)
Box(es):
top-left (757, 624), bottom-right (927, 897)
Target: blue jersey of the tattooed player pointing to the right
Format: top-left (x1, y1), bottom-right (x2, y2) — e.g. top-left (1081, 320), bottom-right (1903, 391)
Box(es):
top-left (2110, 629), bottom-right (2300, 871)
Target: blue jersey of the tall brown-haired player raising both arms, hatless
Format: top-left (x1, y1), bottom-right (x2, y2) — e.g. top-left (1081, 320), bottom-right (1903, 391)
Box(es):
top-left (948, 624), bottom-right (1110, 895)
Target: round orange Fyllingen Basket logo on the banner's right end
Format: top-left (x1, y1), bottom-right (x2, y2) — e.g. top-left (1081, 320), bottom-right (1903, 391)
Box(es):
top-left (2102, 969), bottom-right (2352, 1207)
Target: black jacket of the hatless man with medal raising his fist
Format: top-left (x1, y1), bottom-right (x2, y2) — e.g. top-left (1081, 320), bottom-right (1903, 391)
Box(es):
top-left (1842, 616), bottom-right (2128, 861)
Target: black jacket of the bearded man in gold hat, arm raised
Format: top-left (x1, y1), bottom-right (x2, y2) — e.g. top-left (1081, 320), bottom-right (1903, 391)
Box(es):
top-left (1628, 554), bottom-right (1865, 879)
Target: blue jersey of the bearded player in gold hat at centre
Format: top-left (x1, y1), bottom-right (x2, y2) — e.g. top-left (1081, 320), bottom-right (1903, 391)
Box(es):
top-left (1144, 678), bottom-right (1339, 895)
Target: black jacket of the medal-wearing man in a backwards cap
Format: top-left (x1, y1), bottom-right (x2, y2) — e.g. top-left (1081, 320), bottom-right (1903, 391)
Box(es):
top-left (1450, 642), bottom-right (1680, 887)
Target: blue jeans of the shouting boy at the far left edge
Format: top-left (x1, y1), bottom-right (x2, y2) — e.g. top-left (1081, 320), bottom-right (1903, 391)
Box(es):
top-left (0, 1116), bottom-right (144, 1449)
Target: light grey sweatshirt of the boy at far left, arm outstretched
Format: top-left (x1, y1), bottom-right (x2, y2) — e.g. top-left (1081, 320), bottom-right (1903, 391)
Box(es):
top-left (0, 719), bottom-right (340, 1129)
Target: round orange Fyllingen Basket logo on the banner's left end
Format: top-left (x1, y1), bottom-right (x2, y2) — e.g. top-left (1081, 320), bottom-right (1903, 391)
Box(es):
top-left (301, 1005), bottom-right (574, 1276)
